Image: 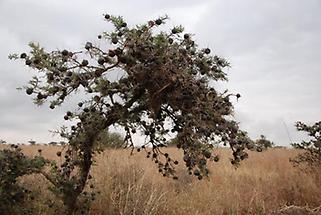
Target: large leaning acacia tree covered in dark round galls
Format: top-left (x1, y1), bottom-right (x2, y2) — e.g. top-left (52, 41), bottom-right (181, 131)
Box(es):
top-left (11, 14), bottom-right (252, 214)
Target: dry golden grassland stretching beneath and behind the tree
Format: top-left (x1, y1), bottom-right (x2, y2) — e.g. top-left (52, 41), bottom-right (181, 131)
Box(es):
top-left (1, 146), bottom-right (321, 215)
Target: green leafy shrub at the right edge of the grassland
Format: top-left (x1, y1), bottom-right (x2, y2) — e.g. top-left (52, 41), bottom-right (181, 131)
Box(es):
top-left (291, 121), bottom-right (321, 171)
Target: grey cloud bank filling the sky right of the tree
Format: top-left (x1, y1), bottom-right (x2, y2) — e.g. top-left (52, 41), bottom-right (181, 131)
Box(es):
top-left (192, 0), bottom-right (321, 145)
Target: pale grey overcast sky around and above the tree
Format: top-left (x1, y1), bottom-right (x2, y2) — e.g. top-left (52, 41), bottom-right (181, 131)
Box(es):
top-left (0, 0), bottom-right (321, 145)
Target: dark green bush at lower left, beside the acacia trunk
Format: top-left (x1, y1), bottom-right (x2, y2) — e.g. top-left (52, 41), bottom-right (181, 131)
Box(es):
top-left (0, 145), bottom-right (46, 214)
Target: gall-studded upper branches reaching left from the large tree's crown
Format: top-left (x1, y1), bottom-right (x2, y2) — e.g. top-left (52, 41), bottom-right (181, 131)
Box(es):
top-left (21, 39), bottom-right (117, 106)
